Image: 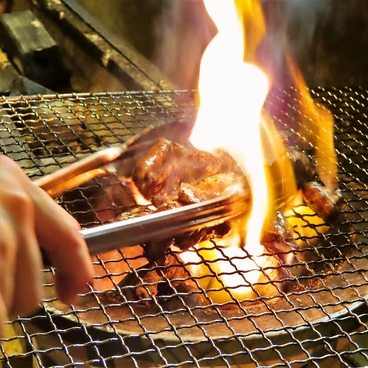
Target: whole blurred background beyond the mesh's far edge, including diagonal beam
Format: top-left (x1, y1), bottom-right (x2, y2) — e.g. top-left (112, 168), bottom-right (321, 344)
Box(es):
top-left (0, 0), bottom-right (368, 94)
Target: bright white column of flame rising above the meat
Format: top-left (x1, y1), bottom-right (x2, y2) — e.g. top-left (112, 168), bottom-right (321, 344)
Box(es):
top-left (191, 0), bottom-right (270, 249)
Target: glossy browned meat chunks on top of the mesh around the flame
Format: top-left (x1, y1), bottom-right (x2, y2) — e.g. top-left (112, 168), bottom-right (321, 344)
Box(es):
top-left (111, 139), bottom-right (339, 264)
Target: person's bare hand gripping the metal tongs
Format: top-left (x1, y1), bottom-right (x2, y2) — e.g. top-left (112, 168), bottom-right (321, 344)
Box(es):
top-left (0, 155), bottom-right (92, 335)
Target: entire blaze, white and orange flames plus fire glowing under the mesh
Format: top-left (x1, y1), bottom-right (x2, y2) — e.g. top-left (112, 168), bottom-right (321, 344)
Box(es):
top-left (181, 0), bottom-right (337, 301)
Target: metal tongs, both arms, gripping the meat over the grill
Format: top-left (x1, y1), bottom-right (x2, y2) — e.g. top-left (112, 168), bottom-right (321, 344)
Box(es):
top-left (34, 122), bottom-right (249, 255)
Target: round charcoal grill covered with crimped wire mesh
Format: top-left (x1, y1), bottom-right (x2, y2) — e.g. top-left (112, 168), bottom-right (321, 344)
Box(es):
top-left (0, 88), bottom-right (368, 367)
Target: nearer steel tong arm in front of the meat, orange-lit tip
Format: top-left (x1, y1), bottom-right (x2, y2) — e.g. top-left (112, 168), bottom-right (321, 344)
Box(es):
top-left (81, 194), bottom-right (249, 255)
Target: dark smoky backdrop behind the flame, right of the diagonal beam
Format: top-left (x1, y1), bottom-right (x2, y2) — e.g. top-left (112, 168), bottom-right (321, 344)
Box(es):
top-left (72, 0), bottom-right (368, 88)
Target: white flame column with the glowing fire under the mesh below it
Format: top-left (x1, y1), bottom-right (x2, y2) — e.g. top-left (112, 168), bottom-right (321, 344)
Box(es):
top-left (181, 0), bottom-right (272, 302)
